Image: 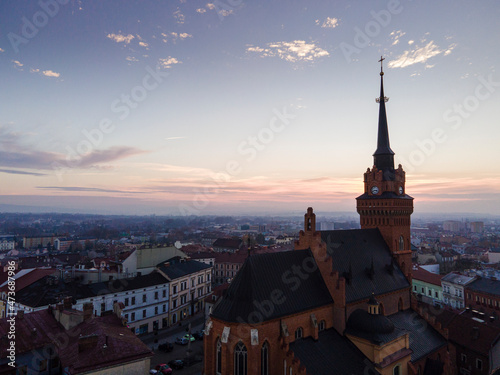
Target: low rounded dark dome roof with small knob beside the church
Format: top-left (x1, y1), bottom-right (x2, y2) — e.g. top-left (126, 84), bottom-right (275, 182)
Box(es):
top-left (345, 309), bottom-right (406, 345)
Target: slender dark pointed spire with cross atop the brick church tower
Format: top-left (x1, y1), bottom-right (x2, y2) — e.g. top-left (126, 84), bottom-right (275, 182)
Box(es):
top-left (373, 56), bottom-right (394, 170)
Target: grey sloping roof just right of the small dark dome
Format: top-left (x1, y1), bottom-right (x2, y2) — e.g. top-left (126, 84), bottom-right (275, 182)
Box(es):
top-left (388, 310), bottom-right (447, 362)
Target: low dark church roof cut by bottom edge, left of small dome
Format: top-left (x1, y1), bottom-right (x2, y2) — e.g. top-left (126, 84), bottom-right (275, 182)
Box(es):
top-left (290, 328), bottom-right (378, 375)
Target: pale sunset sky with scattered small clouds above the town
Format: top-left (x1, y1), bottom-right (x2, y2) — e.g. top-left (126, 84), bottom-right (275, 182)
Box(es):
top-left (0, 0), bottom-right (500, 214)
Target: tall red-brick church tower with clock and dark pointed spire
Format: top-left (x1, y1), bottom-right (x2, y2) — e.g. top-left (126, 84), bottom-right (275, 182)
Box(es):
top-left (356, 58), bottom-right (413, 276)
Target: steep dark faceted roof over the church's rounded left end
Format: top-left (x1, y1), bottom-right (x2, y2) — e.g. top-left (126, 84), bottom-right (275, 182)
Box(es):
top-left (212, 249), bottom-right (333, 324)
